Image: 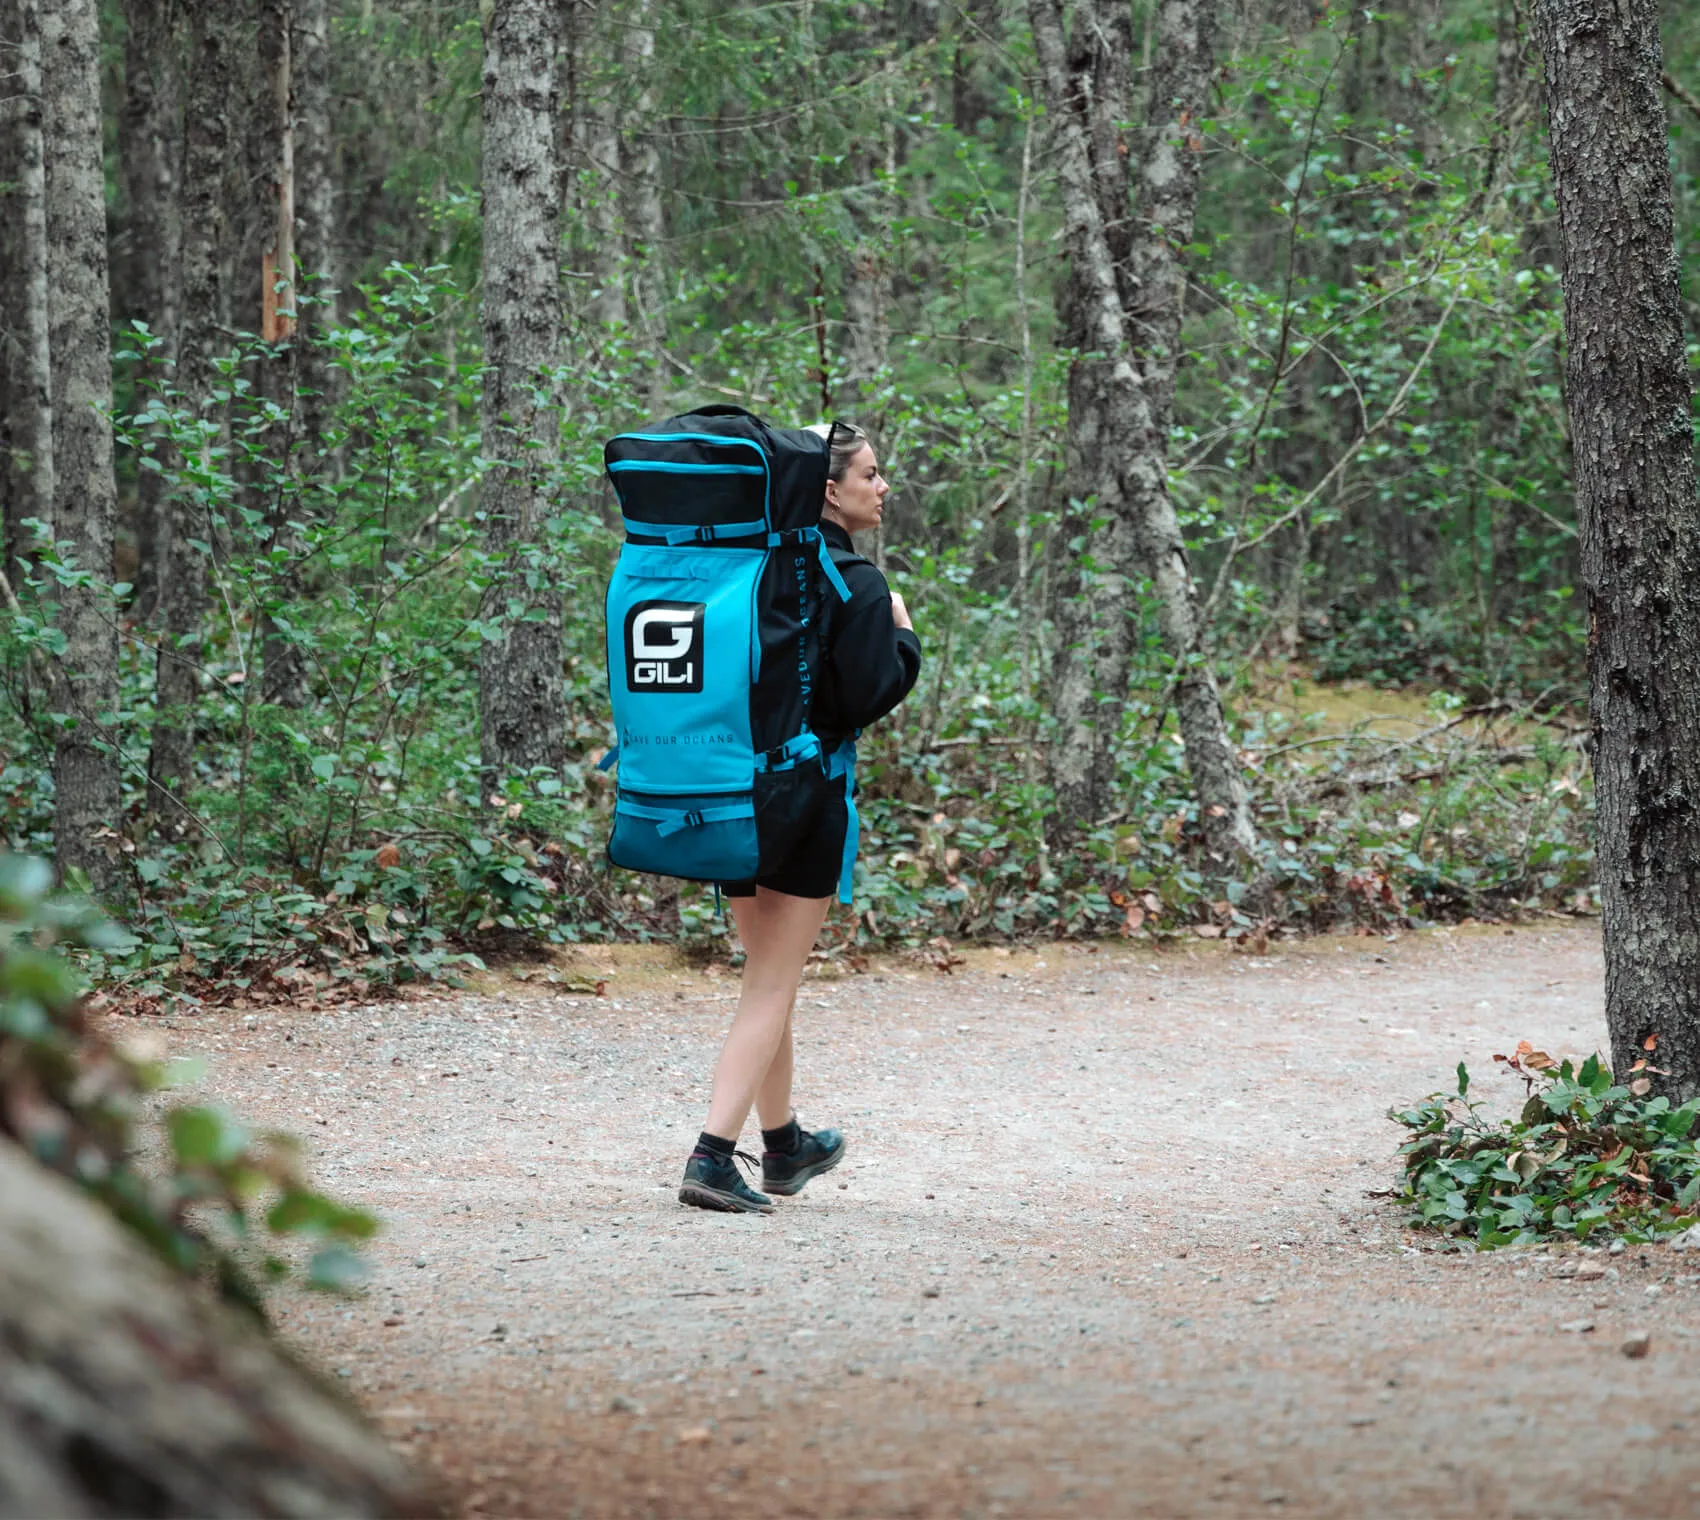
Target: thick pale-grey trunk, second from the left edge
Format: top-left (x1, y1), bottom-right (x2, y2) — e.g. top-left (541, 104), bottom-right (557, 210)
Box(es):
top-left (41, 0), bottom-right (122, 896)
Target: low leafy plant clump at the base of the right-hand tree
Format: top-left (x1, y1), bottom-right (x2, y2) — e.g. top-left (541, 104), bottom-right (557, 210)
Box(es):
top-left (1387, 1041), bottom-right (1700, 1250)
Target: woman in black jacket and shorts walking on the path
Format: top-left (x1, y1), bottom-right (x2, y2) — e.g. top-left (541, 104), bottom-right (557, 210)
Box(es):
top-left (678, 422), bottom-right (921, 1214)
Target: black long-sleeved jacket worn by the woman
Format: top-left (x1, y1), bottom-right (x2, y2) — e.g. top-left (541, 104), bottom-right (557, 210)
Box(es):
top-left (809, 522), bottom-right (921, 748)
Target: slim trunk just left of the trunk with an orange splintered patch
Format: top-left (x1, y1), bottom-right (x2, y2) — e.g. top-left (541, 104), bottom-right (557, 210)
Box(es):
top-left (148, 0), bottom-right (240, 823)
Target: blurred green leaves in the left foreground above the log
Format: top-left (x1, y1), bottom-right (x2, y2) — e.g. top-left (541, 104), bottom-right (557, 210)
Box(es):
top-left (0, 854), bottom-right (377, 1313)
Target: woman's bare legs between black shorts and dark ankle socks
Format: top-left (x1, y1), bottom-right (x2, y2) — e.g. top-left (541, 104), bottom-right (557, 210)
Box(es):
top-left (704, 888), bottom-right (831, 1141)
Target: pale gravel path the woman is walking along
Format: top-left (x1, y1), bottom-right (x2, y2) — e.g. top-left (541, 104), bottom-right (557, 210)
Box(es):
top-left (146, 922), bottom-right (1700, 1520)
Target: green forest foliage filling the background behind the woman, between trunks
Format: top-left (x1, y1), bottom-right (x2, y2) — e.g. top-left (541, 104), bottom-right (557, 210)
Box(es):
top-left (0, 0), bottom-right (1618, 995)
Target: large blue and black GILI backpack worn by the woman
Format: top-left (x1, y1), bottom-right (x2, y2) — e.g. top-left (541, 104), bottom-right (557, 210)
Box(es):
top-left (604, 406), bottom-right (857, 903)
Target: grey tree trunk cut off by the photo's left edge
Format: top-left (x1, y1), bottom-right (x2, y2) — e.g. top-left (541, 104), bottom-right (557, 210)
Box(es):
top-left (0, 0), bottom-right (54, 578)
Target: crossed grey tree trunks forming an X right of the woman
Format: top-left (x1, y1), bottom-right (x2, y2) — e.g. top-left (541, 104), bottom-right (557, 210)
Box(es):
top-left (1030, 0), bottom-right (1256, 860)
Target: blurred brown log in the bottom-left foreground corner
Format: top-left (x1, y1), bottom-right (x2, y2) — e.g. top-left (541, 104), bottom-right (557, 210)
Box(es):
top-left (0, 1149), bottom-right (439, 1520)
